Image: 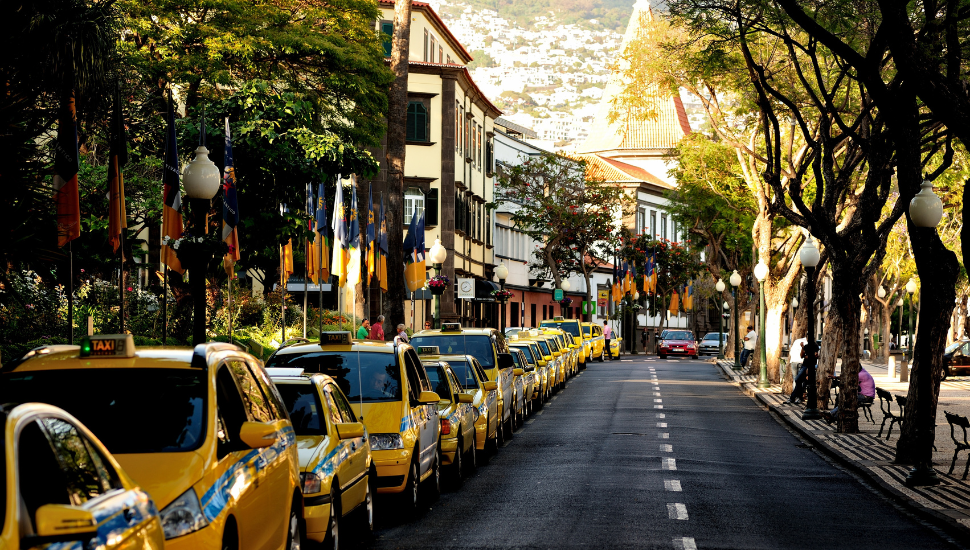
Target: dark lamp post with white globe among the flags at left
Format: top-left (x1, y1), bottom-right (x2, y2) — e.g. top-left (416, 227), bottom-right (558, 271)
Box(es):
top-left (182, 145), bottom-right (222, 346)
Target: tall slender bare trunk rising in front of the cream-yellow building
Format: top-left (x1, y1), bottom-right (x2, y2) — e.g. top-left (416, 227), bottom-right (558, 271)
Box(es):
top-left (384, 0), bottom-right (411, 339)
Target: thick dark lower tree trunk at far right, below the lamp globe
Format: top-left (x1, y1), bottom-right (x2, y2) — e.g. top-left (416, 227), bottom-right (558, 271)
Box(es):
top-left (896, 224), bottom-right (960, 464)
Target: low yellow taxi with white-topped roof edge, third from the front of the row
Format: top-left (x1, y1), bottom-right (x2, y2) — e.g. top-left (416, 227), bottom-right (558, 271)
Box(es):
top-left (268, 368), bottom-right (377, 548)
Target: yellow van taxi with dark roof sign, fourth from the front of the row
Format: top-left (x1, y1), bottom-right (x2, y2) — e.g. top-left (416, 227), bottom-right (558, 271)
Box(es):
top-left (266, 332), bottom-right (441, 513)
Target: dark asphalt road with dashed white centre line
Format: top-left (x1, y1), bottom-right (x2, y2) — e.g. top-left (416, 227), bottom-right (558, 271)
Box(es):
top-left (368, 358), bottom-right (957, 550)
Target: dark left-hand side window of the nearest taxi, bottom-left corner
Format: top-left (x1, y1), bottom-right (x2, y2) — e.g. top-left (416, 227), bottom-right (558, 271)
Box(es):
top-left (17, 422), bottom-right (74, 530)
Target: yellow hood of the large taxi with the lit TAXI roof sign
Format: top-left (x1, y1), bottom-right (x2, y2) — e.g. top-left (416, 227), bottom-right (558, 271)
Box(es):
top-left (115, 452), bottom-right (205, 510)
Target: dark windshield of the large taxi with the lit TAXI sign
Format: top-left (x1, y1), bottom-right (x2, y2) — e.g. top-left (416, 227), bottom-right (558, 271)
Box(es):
top-left (0, 368), bottom-right (208, 454)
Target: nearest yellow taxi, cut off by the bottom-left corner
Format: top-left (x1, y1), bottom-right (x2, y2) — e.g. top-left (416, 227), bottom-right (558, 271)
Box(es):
top-left (0, 403), bottom-right (165, 550)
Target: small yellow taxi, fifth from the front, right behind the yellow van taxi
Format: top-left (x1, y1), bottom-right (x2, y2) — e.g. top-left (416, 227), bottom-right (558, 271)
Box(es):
top-left (422, 353), bottom-right (478, 486)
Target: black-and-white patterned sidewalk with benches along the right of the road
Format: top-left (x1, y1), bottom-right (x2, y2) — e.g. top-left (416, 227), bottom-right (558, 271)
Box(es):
top-left (714, 361), bottom-right (970, 537)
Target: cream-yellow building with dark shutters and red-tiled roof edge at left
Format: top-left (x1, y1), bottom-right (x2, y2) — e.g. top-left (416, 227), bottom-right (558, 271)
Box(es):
top-left (364, 0), bottom-right (501, 328)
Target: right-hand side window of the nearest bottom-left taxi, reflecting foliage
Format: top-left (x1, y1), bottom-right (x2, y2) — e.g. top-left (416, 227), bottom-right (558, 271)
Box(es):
top-left (40, 418), bottom-right (112, 506)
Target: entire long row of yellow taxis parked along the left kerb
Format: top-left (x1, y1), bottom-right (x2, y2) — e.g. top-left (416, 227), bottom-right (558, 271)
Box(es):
top-left (0, 318), bottom-right (603, 550)
